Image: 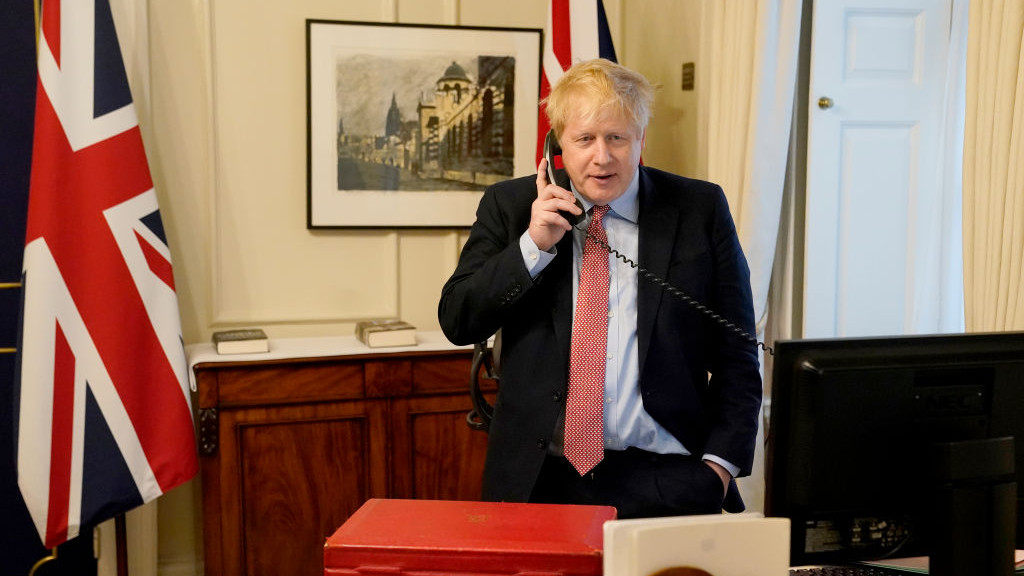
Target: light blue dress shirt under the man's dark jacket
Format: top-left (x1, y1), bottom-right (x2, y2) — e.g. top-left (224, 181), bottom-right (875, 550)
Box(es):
top-left (519, 170), bottom-right (739, 477)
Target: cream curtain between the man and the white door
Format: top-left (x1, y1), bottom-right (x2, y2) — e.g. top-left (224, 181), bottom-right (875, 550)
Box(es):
top-left (697, 0), bottom-right (802, 511)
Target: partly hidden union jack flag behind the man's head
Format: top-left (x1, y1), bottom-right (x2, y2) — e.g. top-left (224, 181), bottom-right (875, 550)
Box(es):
top-left (537, 0), bottom-right (616, 162)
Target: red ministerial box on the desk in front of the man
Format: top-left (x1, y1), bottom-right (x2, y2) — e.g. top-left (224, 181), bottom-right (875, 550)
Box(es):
top-left (324, 498), bottom-right (615, 576)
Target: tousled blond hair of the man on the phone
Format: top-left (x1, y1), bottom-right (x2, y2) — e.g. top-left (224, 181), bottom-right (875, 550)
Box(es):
top-left (544, 58), bottom-right (654, 138)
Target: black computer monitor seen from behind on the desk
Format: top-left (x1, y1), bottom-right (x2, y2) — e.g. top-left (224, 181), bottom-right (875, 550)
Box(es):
top-left (765, 333), bottom-right (1024, 574)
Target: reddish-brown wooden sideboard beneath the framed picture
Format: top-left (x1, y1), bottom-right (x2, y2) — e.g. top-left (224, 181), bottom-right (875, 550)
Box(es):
top-left (193, 340), bottom-right (495, 576)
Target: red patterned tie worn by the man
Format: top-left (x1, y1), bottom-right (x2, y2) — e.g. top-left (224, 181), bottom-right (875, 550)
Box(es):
top-left (565, 206), bottom-right (608, 476)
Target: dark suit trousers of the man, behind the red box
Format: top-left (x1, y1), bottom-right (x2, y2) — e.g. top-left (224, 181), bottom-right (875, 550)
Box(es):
top-left (529, 448), bottom-right (742, 519)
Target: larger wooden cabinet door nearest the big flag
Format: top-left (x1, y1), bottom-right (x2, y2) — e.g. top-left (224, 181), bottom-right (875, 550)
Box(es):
top-left (220, 400), bottom-right (388, 576)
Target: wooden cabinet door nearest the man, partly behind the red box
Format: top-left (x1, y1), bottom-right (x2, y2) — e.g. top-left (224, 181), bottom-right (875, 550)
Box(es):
top-left (391, 393), bottom-right (487, 500)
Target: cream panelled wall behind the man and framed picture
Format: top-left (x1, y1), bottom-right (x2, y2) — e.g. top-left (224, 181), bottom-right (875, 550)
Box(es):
top-left (130, 0), bottom-right (703, 575)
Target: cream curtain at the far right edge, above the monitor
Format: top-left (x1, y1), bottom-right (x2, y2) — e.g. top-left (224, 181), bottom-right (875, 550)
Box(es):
top-left (964, 0), bottom-right (1024, 332)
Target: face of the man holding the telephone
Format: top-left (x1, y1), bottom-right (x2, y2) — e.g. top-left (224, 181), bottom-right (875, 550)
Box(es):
top-left (559, 108), bottom-right (644, 205)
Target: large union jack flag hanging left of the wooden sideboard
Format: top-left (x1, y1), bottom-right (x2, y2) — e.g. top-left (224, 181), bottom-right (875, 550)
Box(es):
top-left (14, 0), bottom-right (198, 547)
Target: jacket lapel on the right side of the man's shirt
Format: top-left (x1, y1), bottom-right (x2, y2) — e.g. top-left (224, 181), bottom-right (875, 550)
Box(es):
top-left (637, 167), bottom-right (679, 381)
